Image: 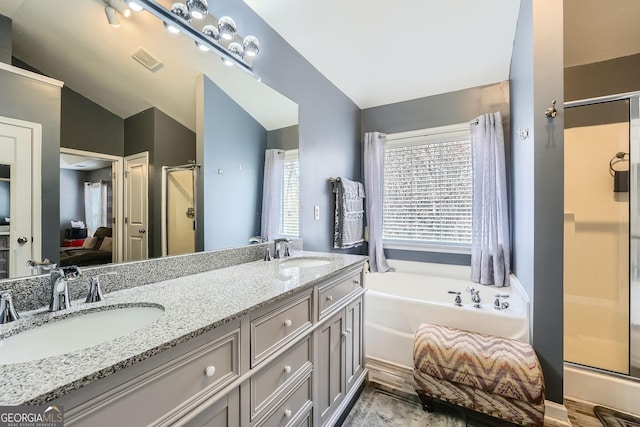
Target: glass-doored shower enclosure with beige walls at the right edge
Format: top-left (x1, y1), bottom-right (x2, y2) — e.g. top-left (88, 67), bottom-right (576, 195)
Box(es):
top-left (564, 93), bottom-right (640, 377)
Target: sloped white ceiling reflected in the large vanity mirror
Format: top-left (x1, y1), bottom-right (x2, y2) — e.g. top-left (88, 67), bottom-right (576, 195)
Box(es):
top-left (0, 0), bottom-right (298, 130)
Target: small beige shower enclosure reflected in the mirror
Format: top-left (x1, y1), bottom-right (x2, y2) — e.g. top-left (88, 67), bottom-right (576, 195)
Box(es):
top-left (162, 164), bottom-right (200, 255)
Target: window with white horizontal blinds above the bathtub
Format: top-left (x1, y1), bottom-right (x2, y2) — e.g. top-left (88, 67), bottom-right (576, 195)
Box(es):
top-left (382, 123), bottom-right (472, 252)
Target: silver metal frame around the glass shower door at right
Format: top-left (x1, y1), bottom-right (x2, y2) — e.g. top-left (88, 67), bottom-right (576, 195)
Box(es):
top-left (564, 91), bottom-right (640, 380)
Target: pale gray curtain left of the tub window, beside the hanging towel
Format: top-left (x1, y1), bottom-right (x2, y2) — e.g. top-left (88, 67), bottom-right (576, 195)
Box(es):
top-left (364, 132), bottom-right (389, 273)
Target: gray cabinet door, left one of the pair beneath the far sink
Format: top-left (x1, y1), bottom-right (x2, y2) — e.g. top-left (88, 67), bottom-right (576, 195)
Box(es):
top-left (316, 310), bottom-right (346, 425)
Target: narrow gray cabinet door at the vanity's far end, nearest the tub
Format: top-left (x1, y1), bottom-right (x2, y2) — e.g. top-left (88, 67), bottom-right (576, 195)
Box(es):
top-left (345, 297), bottom-right (364, 392)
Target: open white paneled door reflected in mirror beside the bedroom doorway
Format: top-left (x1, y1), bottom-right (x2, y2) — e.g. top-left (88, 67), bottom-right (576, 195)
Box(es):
top-left (124, 152), bottom-right (149, 261)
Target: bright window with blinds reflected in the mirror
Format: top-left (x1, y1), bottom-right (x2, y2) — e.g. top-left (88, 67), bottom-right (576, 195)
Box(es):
top-left (280, 150), bottom-right (300, 237)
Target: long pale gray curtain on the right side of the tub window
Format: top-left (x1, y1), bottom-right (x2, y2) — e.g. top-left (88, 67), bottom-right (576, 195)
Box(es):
top-left (471, 112), bottom-right (511, 286)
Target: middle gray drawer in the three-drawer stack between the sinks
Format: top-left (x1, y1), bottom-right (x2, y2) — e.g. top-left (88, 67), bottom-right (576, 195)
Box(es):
top-left (251, 337), bottom-right (311, 419)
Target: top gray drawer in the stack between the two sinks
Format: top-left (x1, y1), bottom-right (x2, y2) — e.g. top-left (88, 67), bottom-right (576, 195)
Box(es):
top-left (251, 294), bottom-right (311, 367)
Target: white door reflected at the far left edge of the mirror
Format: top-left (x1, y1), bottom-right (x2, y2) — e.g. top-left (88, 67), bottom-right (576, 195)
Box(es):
top-left (0, 117), bottom-right (42, 277)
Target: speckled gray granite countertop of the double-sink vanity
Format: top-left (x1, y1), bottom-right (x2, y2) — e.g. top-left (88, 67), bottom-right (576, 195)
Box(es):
top-left (0, 252), bottom-right (366, 405)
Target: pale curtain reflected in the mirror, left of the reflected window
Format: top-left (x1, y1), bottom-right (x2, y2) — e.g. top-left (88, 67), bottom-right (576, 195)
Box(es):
top-left (260, 150), bottom-right (284, 241)
